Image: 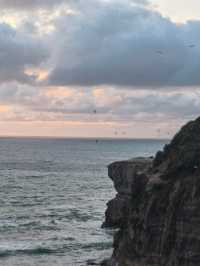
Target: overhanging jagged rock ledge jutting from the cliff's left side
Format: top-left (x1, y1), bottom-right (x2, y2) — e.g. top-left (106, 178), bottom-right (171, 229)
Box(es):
top-left (102, 158), bottom-right (153, 227)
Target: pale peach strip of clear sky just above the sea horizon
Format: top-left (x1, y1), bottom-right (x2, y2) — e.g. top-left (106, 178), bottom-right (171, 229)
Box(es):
top-left (0, 121), bottom-right (182, 139)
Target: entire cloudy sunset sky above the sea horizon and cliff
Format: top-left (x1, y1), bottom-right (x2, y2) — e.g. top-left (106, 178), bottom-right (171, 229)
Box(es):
top-left (0, 0), bottom-right (200, 138)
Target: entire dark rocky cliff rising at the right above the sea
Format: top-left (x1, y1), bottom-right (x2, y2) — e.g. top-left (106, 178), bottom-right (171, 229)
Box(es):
top-left (103, 118), bottom-right (200, 266)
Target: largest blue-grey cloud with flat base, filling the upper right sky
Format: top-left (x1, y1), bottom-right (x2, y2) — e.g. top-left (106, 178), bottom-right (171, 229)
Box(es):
top-left (49, 1), bottom-right (200, 88)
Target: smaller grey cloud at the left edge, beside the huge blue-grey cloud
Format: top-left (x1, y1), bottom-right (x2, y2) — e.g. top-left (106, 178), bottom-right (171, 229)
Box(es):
top-left (0, 24), bottom-right (48, 83)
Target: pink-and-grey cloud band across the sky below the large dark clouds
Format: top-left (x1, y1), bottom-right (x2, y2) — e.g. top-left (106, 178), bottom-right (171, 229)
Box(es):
top-left (0, 82), bottom-right (200, 125)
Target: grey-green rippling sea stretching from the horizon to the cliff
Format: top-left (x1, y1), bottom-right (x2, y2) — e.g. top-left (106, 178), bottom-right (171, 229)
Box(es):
top-left (0, 138), bottom-right (168, 266)
